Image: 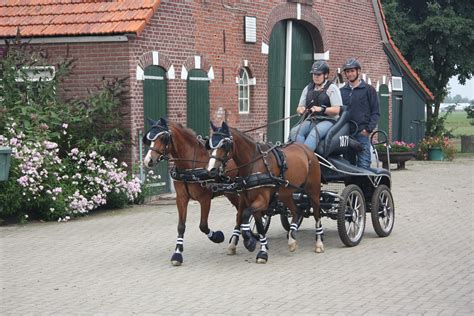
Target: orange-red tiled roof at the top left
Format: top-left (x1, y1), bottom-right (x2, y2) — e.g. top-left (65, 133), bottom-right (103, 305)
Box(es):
top-left (0, 0), bottom-right (160, 37)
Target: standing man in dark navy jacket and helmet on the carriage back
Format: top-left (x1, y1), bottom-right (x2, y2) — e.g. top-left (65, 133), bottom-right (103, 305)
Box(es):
top-left (341, 58), bottom-right (380, 168)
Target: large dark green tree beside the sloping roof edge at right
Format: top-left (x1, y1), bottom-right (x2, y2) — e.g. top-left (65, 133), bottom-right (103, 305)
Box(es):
top-left (382, 0), bottom-right (474, 135)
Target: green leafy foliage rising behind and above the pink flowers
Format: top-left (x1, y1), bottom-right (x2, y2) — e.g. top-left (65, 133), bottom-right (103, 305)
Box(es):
top-left (0, 37), bottom-right (128, 158)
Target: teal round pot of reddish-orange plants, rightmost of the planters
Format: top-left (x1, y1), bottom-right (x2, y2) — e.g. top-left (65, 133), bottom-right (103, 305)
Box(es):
top-left (418, 136), bottom-right (455, 161)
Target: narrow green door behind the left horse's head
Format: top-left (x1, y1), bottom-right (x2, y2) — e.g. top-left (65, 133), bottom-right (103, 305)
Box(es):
top-left (143, 66), bottom-right (169, 195)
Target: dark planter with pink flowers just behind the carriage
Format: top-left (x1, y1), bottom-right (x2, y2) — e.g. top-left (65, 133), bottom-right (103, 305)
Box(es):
top-left (375, 140), bottom-right (416, 169)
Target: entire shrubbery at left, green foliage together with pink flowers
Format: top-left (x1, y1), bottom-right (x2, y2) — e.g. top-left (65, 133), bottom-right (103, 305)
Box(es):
top-left (0, 38), bottom-right (143, 221)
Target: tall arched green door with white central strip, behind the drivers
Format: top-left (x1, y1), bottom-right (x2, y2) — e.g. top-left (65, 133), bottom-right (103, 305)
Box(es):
top-left (267, 21), bottom-right (314, 142)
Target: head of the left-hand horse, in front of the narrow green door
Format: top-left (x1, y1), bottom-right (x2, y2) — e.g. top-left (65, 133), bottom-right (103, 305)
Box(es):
top-left (142, 118), bottom-right (171, 167)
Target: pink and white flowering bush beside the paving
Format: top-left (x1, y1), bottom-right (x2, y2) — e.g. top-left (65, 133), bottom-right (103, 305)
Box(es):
top-left (0, 123), bottom-right (141, 221)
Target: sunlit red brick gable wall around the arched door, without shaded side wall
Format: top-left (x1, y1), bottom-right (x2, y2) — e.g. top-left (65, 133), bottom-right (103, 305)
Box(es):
top-left (130, 0), bottom-right (389, 148)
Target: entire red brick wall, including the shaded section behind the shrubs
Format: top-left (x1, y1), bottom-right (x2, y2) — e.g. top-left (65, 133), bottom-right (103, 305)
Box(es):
top-left (3, 0), bottom-right (391, 162)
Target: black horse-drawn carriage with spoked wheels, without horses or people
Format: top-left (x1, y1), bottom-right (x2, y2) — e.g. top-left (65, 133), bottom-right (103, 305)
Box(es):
top-left (211, 107), bottom-right (395, 247)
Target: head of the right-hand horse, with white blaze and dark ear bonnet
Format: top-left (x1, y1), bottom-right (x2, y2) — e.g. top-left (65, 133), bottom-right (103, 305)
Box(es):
top-left (206, 122), bottom-right (233, 177)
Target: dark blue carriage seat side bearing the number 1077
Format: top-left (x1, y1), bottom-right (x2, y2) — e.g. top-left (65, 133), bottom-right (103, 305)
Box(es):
top-left (315, 105), bottom-right (362, 158)
